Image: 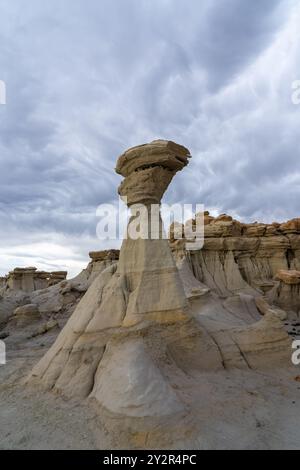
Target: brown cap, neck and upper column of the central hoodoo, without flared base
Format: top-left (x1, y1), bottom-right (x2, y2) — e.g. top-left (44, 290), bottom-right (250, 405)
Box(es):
top-left (116, 140), bottom-right (190, 326)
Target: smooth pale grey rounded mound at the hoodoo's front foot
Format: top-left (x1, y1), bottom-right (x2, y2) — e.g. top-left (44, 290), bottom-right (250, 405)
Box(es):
top-left (90, 338), bottom-right (183, 418)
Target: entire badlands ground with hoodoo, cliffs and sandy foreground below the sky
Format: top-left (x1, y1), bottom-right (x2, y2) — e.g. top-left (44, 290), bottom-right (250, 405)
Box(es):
top-left (0, 140), bottom-right (300, 449)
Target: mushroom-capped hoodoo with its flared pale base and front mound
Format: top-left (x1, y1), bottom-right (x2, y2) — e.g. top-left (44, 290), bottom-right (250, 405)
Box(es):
top-left (30, 142), bottom-right (192, 426)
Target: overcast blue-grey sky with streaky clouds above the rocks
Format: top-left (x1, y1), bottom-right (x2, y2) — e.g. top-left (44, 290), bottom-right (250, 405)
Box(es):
top-left (0, 0), bottom-right (300, 275)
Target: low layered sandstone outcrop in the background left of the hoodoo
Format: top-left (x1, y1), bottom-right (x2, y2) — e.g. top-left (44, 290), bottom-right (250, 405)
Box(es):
top-left (0, 250), bottom-right (119, 335)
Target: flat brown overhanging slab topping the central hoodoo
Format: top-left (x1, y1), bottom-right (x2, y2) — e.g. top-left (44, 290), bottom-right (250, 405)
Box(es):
top-left (116, 140), bottom-right (191, 177)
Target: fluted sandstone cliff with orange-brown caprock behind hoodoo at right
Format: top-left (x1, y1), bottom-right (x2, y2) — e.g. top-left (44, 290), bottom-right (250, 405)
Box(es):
top-left (170, 212), bottom-right (300, 309)
